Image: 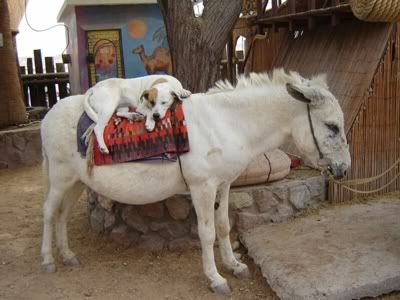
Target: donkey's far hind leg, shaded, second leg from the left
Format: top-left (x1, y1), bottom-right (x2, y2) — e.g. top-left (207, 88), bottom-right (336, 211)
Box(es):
top-left (56, 182), bottom-right (84, 266)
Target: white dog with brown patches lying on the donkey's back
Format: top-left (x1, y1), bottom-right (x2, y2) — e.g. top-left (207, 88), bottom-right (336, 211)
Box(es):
top-left (84, 75), bottom-right (191, 153)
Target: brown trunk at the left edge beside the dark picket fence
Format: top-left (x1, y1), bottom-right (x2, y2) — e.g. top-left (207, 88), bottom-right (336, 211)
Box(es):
top-left (0, 0), bottom-right (26, 127)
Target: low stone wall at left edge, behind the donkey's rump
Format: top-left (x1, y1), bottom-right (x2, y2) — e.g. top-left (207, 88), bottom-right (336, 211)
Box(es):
top-left (0, 124), bottom-right (42, 169)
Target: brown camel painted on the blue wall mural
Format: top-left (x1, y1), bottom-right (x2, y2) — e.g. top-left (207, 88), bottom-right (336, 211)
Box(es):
top-left (132, 45), bottom-right (172, 75)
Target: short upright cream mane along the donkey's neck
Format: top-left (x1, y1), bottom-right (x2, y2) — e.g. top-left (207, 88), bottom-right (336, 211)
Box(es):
top-left (207, 68), bottom-right (328, 94)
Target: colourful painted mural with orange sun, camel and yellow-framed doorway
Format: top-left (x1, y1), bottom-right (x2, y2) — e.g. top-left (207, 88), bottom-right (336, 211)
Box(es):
top-left (77, 5), bottom-right (172, 86)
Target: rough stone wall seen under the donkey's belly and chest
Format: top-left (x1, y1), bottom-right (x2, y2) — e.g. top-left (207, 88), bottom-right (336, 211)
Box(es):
top-left (88, 176), bottom-right (326, 251)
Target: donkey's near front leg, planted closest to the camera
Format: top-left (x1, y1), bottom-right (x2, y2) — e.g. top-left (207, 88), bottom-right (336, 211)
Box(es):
top-left (190, 184), bottom-right (231, 294)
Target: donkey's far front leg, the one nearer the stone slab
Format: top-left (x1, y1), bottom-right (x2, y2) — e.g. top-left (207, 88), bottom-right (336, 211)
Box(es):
top-left (215, 184), bottom-right (250, 278)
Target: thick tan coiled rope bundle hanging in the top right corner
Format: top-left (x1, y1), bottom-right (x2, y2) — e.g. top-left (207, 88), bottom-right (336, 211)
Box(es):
top-left (350, 0), bottom-right (400, 22)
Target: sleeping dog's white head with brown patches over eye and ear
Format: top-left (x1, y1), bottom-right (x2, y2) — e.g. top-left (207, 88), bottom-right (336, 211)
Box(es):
top-left (141, 79), bottom-right (180, 121)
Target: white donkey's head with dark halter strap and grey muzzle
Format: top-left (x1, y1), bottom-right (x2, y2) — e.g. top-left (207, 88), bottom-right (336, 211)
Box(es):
top-left (286, 75), bottom-right (351, 178)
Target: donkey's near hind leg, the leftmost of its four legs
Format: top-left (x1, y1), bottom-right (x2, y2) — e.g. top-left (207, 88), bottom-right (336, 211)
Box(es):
top-left (41, 166), bottom-right (76, 272)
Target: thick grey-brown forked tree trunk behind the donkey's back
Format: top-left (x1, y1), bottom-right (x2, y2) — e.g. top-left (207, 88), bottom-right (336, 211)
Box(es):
top-left (158, 0), bottom-right (242, 93)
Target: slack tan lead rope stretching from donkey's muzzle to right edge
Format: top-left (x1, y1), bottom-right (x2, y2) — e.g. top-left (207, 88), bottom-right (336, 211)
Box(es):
top-left (329, 158), bottom-right (400, 194)
